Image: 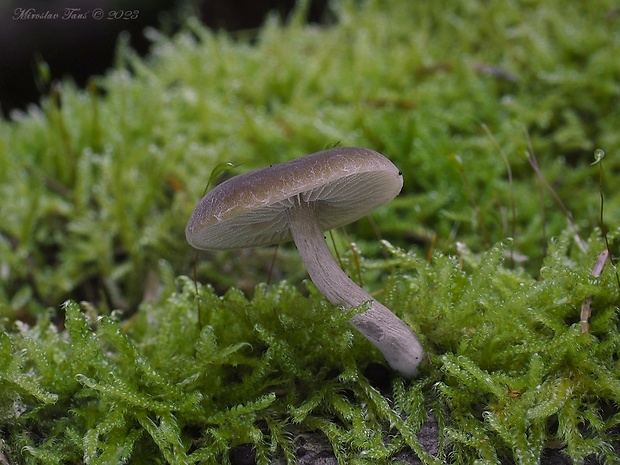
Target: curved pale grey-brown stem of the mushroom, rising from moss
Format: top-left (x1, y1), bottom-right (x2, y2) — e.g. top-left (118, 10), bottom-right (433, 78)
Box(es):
top-left (288, 200), bottom-right (424, 377)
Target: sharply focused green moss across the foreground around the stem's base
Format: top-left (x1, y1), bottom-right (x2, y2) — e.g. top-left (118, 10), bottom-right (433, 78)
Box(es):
top-left (0, 236), bottom-right (620, 464)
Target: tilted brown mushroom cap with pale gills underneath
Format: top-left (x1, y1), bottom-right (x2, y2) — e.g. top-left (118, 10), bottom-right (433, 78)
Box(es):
top-left (185, 147), bottom-right (403, 250)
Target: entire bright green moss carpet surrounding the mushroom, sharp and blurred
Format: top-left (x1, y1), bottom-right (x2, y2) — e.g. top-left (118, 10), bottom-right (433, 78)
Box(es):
top-left (0, 0), bottom-right (620, 464)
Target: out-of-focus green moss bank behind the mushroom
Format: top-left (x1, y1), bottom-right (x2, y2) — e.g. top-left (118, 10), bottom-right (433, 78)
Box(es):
top-left (0, 1), bottom-right (620, 316)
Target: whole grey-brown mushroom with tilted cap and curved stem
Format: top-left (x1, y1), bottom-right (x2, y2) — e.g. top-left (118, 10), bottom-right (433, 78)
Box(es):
top-left (185, 147), bottom-right (424, 377)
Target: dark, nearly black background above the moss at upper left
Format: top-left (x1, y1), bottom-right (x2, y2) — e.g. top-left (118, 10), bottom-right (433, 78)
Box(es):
top-left (0, 0), bottom-right (327, 116)
